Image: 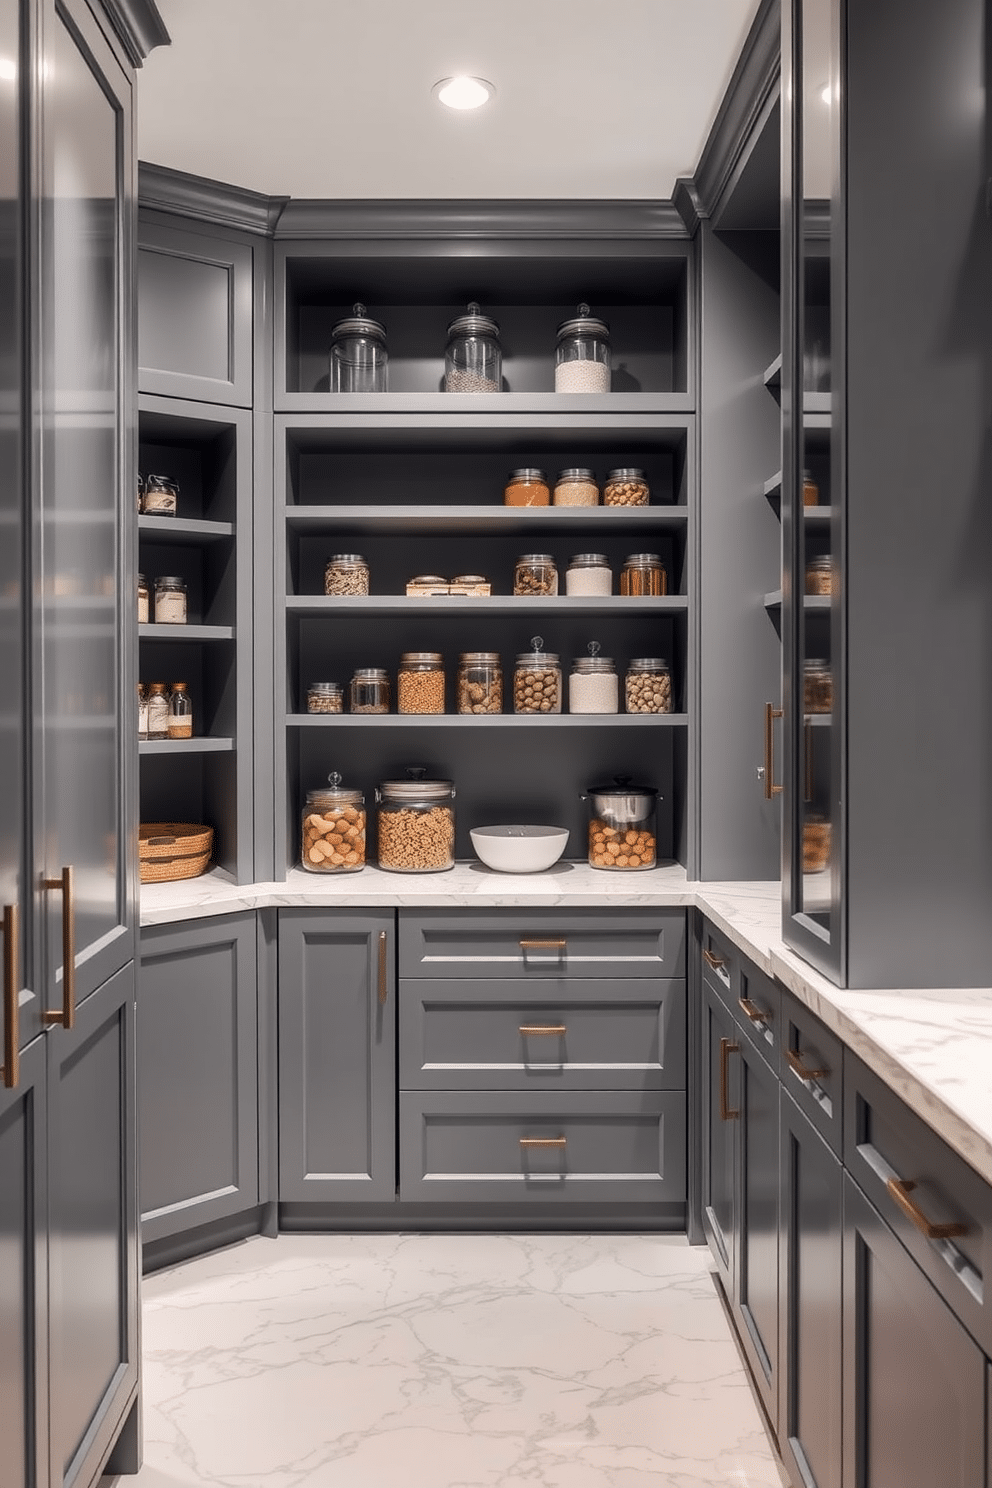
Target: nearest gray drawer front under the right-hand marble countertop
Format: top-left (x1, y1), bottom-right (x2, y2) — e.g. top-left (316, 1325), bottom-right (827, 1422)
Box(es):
top-left (843, 1051), bottom-right (992, 1354)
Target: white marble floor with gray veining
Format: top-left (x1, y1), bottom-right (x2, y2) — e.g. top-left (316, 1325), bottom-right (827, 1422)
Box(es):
top-left (110, 1235), bottom-right (784, 1488)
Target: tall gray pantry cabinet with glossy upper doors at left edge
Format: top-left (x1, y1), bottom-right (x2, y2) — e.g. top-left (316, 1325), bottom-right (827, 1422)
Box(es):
top-left (0, 0), bottom-right (165, 1488)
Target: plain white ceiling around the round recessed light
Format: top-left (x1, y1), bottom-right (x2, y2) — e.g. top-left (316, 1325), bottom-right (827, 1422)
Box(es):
top-left (138, 0), bottom-right (759, 198)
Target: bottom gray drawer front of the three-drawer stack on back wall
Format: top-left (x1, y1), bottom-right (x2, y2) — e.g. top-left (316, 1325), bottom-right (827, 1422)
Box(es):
top-left (400, 1091), bottom-right (686, 1204)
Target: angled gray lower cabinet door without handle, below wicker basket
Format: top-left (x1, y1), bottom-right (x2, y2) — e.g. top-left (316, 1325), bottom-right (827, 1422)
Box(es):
top-left (137, 914), bottom-right (259, 1242)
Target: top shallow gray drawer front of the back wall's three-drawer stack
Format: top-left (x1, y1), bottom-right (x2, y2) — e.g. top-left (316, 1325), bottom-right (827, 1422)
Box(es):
top-left (400, 909), bottom-right (686, 981)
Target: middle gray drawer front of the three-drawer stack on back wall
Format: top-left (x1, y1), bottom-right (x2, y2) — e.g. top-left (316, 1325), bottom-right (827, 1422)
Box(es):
top-left (400, 978), bottom-right (686, 1091)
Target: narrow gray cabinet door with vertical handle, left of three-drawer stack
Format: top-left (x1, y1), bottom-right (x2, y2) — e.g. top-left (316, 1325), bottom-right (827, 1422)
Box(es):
top-left (280, 909), bottom-right (396, 1204)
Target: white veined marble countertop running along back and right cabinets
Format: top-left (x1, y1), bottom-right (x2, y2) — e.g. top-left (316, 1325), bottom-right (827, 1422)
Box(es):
top-left (141, 863), bottom-right (992, 1183)
